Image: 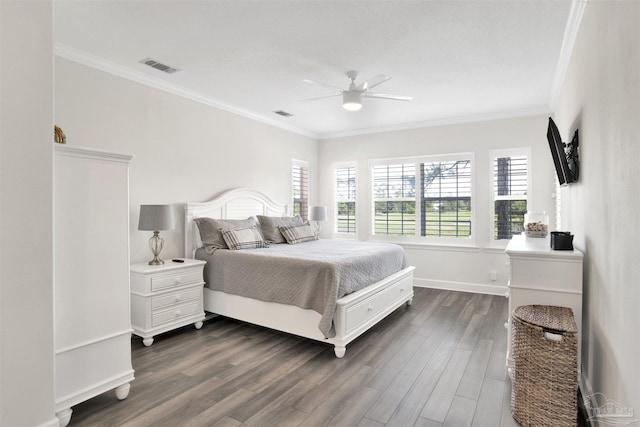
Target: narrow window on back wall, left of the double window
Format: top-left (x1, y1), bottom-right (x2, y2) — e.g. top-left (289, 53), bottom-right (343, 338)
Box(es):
top-left (334, 166), bottom-right (356, 234)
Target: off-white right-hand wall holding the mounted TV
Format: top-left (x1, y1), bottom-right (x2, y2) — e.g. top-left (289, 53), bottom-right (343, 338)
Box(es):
top-left (555, 1), bottom-right (640, 418)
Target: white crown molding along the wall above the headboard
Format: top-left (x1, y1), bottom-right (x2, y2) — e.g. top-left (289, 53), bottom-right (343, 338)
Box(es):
top-left (54, 43), bottom-right (318, 139)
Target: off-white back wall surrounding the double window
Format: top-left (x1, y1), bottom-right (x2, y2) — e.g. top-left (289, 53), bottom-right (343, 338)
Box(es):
top-left (318, 113), bottom-right (555, 294)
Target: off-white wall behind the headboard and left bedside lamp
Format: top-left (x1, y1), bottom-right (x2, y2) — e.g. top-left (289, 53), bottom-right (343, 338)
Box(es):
top-left (55, 57), bottom-right (317, 263)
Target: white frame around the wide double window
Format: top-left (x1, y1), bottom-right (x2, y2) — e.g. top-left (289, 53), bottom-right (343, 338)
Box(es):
top-left (369, 152), bottom-right (478, 246)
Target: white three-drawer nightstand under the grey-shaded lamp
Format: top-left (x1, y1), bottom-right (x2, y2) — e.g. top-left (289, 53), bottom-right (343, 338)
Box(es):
top-left (129, 259), bottom-right (206, 347)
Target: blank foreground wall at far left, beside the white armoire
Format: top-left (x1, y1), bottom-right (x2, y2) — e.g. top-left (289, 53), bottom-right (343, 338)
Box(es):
top-left (0, 0), bottom-right (57, 427)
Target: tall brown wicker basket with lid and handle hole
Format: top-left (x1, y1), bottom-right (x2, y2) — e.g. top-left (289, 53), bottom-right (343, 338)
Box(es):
top-left (511, 305), bottom-right (578, 427)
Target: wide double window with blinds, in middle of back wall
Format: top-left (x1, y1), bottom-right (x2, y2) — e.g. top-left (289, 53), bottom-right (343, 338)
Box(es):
top-left (372, 154), bottom-right (472, 239)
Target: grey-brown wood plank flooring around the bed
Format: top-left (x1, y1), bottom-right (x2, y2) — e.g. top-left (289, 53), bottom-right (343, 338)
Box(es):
top-left (70, 288), bottom-right (584, 427)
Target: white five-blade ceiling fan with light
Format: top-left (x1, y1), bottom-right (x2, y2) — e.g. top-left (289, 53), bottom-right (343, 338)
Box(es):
top-left (303, 71), bottom-right (413, 111)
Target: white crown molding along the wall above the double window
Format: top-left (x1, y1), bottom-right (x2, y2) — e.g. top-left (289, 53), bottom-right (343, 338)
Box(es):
top-left (319, 105), bottom-right (551, 140)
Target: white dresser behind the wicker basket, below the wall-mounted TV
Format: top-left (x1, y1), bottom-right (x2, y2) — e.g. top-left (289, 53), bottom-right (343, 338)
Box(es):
top-left (505, 236), bottom-right (583, 373)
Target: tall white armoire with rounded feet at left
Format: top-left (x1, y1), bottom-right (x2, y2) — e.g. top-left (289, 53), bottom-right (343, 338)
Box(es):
top-left (54, 144), bottom-right (133, 426)
